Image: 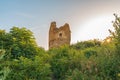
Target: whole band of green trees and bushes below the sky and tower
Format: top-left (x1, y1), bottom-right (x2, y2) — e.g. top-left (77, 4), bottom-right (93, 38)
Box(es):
top-left (0, 15), bottom-right (120, 80)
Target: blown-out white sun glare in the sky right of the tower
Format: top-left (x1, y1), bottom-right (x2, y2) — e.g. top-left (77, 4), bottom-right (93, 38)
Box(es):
top-left (76, 15), bottom-right (114, 41)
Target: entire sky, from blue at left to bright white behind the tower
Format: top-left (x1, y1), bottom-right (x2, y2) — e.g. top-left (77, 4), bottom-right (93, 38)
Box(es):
top-left (0, 0), bottom-right (120, 49)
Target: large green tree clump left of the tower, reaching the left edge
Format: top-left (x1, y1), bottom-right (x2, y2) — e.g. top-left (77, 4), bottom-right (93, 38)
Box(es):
top-left (0, 27), bottom-right (40, 59)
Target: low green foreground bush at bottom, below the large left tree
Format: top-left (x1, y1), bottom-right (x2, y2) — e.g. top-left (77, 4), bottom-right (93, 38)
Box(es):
top-left (6, 56), bottom-right (51, 80)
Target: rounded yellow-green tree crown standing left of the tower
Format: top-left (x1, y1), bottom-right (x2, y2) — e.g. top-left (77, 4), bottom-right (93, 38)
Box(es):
top-left (10, 27), bottom-right (38, 58)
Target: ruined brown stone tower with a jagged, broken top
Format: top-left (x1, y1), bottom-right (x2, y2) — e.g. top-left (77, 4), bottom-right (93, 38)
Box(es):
top-left (49, 22), bottom-right (71, 49)
